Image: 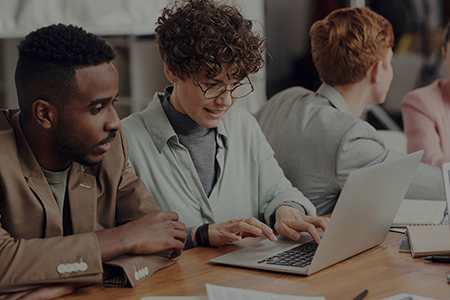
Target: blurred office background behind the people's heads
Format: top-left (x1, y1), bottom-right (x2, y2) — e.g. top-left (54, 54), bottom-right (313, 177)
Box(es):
top-left (0, 0), bottom-right (450, 130)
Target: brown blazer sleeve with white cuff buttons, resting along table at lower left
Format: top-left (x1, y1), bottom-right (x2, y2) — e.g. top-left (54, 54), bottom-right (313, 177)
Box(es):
top-left (0, 233), bottom-right (103, 293)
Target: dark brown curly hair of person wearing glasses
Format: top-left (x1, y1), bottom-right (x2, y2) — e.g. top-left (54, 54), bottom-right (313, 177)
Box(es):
top-left (156, 0), bottom-right (267, 80)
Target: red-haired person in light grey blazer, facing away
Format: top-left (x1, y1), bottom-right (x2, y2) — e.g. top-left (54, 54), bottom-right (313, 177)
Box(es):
top-left (256, 8), bottom-right (444, 215)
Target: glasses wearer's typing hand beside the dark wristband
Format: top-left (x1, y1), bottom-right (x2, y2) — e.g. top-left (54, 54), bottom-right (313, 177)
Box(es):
top-left (206, 217), bottom-right (277, 247)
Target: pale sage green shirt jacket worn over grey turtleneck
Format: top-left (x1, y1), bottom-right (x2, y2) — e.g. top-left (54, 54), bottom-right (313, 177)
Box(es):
top-left (122, 93), bottom-right (316, 227)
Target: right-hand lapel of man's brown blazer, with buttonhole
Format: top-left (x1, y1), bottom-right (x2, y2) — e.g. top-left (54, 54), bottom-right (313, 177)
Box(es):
top-left (67, 163), bottom-right (97, 234)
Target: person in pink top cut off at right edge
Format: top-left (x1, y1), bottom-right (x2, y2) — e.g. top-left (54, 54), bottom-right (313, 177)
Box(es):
top-left (400, 21), bottom-right (450, 167)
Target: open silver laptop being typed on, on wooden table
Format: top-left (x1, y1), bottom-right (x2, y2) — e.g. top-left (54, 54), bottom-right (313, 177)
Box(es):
top-left (210, 151), bottom-right (423, 275)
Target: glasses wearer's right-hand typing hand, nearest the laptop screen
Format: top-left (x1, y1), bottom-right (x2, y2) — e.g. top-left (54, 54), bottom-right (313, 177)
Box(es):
top-left (275, 205), bottom-right (330, 244)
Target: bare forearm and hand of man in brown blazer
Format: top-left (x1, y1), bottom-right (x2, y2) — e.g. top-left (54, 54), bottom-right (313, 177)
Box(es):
top-left (96, 211), bottom-right (187, 261)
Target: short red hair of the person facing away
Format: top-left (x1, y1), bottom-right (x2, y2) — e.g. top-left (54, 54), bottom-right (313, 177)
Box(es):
top-left (310, 7), bottom-right (394, 85)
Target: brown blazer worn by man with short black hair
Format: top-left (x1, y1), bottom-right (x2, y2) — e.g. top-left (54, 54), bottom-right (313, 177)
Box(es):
top-left (0, 110), bottom-right (175, 293)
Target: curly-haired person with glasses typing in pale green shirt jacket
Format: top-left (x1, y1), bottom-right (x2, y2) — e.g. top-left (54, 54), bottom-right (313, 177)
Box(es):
top-left (122, 0), bottom-right (328, 249)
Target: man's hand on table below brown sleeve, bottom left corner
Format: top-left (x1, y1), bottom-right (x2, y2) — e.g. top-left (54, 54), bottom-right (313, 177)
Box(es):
top-left (0, 283), bottom-right (78, 300)
